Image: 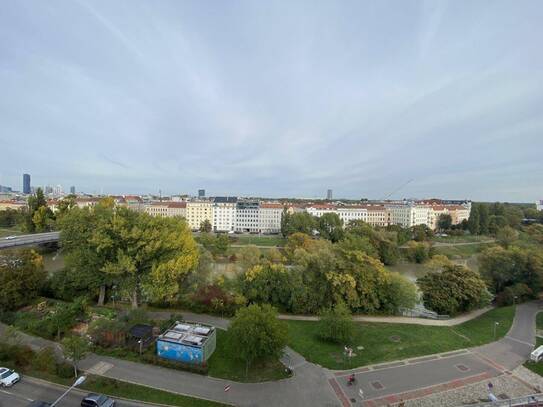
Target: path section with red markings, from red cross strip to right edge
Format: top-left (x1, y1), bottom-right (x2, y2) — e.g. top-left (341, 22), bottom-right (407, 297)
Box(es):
top-left (333, 302), bottom-right (543, 406)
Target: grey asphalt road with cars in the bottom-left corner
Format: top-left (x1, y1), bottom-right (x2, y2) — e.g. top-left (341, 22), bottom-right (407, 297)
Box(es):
top-left (0, 377), bottom-right (152, 407)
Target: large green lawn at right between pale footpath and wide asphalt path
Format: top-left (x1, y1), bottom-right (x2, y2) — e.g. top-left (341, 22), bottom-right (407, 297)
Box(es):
top-left (287, 306), bottom-right (515, 369)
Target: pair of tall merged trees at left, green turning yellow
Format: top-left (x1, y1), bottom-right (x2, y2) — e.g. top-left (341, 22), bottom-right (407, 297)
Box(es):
top-left (61, 200), bottom-right (198, 307)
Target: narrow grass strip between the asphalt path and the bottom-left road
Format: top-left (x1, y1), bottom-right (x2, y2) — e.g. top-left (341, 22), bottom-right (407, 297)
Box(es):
top-left (19, 369), bottom-right (228, 407)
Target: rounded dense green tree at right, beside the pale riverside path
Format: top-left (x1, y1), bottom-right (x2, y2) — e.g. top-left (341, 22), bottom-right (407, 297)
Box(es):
top-left (417, 265), bottom-right (491, 315)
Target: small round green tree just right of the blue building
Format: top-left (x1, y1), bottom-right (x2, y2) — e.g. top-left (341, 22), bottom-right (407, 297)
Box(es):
top-left (228, 304), bottom-right (288, 376)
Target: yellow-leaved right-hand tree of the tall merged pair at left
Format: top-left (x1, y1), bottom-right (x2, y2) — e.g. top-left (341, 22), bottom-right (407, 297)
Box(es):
top-left (99, 207), bottom-right (198, 308)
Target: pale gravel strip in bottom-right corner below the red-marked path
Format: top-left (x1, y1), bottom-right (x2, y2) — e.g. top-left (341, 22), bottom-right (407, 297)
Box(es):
top-left (395, 369), bottom-right (534, 407)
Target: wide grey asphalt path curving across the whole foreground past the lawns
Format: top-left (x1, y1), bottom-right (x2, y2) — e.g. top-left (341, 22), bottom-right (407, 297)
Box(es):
top-left (0, 302), bottom-right (543, 407)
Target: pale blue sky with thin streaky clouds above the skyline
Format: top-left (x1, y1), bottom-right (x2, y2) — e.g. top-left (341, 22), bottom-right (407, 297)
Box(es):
top-left (0, 0), bottom-right (543, 202)
